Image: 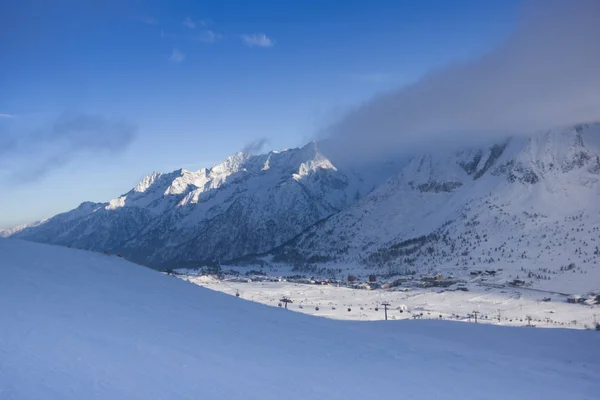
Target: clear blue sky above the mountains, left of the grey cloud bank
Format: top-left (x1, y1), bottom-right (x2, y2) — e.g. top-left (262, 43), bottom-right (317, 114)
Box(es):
top-left (0, 0), bottom-right (520, 228)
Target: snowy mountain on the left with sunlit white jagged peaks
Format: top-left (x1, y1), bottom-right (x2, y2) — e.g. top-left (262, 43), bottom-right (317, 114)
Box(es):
top-left (7, 143), bottom-right (365, 266)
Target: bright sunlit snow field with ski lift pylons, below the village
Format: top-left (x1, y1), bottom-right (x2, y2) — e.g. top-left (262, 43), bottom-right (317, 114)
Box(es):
top-left (182, 276), bottom-right (600, 329)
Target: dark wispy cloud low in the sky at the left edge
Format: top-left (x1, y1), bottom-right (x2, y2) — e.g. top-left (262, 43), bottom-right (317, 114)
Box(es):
top-left (0, 113), bottom-right (136, 182)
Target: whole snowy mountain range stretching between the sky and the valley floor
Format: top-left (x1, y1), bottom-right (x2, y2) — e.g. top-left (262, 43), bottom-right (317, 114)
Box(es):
top-left (10, 125), bottom-right (600, 289)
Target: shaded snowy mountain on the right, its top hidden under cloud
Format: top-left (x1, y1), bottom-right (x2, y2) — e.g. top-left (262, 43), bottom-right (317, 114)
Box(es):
top-left (275, 125), bottom-right (600, 290)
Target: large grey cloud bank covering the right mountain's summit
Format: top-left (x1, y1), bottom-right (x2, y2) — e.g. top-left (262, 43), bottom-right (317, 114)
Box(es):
top-left (321, 0), bottom-right (600, 162)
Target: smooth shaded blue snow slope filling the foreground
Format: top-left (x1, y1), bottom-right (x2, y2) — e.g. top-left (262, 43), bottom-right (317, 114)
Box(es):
top-left (0, 239), bottom-right (600, 400)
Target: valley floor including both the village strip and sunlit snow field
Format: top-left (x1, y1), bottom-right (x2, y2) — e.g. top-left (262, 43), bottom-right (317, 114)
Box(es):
top-left (168, 267), bottom-right (600, 330)
